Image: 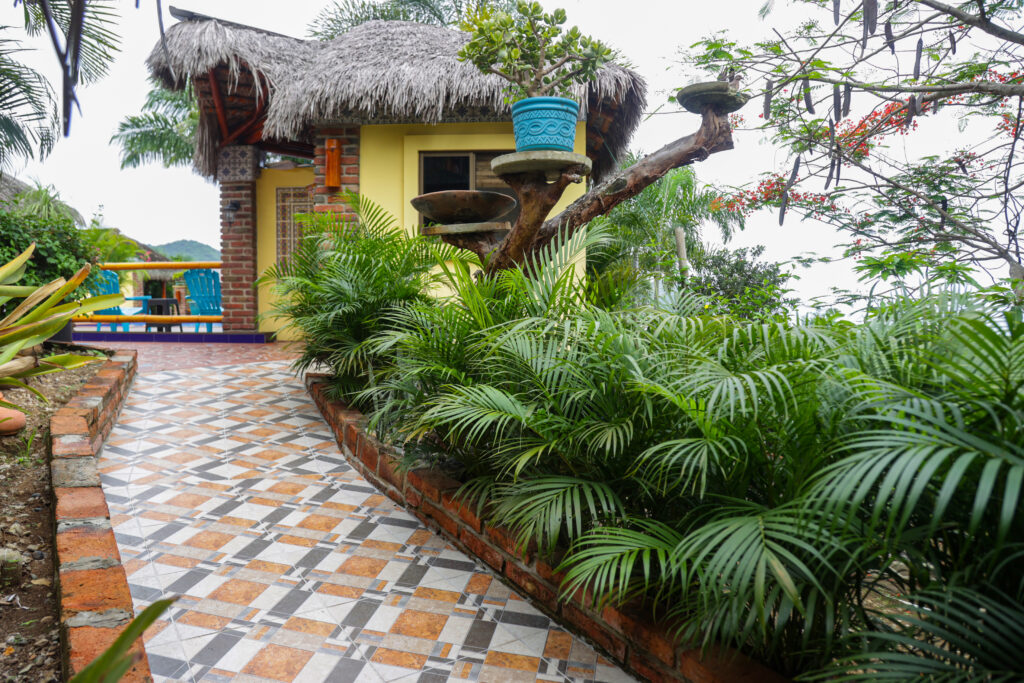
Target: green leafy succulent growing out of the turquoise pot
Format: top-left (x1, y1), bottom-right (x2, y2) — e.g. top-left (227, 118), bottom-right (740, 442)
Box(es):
top-left (459, 0), bottom-right (611, 100)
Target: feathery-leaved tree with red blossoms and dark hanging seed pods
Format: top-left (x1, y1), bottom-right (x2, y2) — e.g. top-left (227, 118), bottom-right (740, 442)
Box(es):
top-left (687, 0), bottom-right (1024, 281)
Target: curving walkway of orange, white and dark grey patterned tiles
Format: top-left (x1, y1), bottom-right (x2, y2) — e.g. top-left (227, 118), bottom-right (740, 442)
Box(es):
top-left (100, 348), bottom-right (632, 683)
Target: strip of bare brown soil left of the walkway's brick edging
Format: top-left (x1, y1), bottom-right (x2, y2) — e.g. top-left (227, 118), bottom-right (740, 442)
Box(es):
top-left (0, 348), bottom-right (105, 683)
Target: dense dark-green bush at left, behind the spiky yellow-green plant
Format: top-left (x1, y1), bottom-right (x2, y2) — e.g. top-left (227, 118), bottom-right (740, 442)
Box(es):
top-left (0, 205), bottom-right (96, 286)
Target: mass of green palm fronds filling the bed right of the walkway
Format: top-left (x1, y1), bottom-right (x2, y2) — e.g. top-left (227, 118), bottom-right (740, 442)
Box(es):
top-left (266, 200), bottom-right (1024, 680)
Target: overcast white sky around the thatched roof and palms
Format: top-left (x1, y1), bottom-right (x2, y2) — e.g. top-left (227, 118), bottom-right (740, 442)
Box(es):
top-left (0, 0), bottom-right (872, 305)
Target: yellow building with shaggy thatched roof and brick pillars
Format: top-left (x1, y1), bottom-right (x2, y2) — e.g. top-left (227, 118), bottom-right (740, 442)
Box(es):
top-left (148, 10), bottom-right (645, 332)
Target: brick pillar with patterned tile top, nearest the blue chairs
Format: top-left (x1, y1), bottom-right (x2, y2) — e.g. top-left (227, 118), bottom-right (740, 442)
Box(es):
top-left (217, 145), bottom-right (259, 332)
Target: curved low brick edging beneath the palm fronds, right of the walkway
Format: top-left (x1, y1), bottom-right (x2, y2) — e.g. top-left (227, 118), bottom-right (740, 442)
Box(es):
top-left (306, 374), bottom-right (786, 683)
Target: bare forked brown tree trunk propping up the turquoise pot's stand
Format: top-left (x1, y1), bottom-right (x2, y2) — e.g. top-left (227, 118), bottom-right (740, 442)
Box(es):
top-left (486, 106), bottom-right (733, 273)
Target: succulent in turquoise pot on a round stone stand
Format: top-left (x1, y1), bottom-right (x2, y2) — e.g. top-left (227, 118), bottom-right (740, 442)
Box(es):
top-left (459, 0), bottom-right (611, 152)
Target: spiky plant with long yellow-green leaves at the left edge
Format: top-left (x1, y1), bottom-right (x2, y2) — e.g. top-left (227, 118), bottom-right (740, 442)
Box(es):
top-left (0, 245), bottom-right (124, 409)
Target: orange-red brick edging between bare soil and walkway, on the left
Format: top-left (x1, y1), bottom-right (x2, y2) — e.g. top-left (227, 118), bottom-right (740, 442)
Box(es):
top-left (50, 350), bottom-right (152, 681)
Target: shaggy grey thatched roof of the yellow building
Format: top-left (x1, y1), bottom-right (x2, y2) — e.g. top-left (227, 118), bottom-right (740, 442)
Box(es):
top-left (147, 11), bottom-right (646, 177)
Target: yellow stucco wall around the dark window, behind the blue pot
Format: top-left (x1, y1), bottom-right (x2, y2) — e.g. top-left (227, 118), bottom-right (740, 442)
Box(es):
top-left (359, 122), bottom-right (587, 230)
